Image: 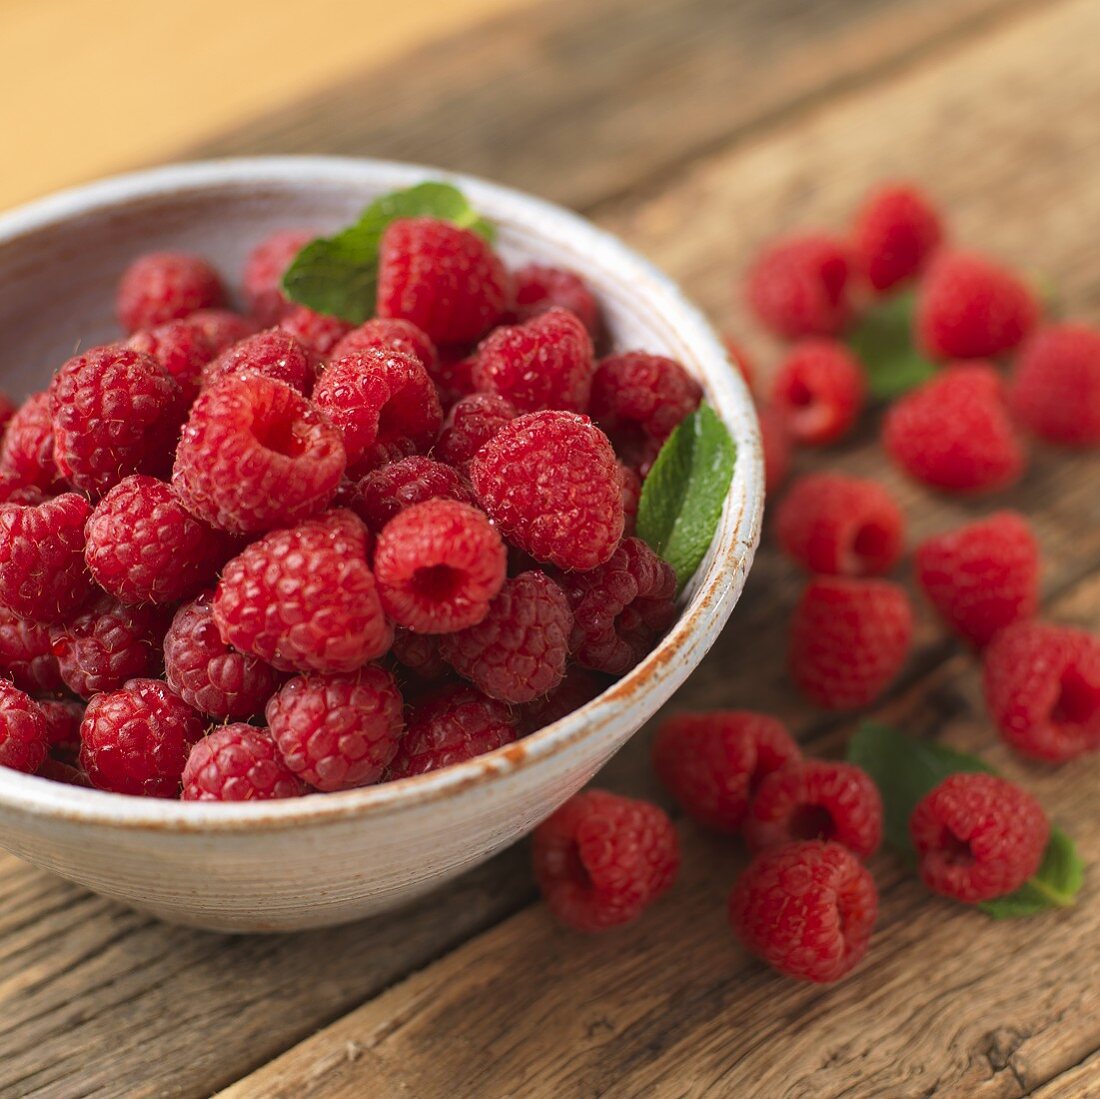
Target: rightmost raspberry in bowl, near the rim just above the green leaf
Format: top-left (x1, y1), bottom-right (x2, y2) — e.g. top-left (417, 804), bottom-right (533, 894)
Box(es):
top-left (592, 351), bottom-right (703, 475)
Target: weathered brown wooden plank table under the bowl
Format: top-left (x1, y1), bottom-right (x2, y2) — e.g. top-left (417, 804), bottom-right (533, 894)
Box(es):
top-left (0, 0), bottom-right (1100, 1099)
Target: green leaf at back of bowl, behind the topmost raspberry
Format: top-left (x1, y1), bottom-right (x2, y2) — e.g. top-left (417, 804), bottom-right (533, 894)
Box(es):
top-left (283, 183), bottom-right (495, 325)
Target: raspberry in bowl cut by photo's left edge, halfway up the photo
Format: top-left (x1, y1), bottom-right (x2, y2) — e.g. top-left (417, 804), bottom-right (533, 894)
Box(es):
top-left (0, 492), bottom-right (94, 623)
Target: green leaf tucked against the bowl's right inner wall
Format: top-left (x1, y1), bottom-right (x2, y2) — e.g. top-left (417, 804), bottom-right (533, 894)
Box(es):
top-left (638, 405), bottom-right (736, 587)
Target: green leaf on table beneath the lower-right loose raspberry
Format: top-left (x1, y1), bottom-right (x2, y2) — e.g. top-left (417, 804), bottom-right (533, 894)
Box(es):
top-left (848, 722), bottom-right (1085, 920)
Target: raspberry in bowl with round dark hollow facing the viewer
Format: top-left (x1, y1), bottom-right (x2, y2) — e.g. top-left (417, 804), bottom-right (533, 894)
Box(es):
top-left (374, 499), bottom-right (507, 634)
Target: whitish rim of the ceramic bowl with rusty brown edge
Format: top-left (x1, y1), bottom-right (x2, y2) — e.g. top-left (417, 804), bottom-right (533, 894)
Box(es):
top-left (0, 156), bottom-right (765, 833)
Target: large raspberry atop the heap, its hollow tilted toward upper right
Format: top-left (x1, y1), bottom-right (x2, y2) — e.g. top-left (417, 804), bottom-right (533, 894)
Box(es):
top-left (172, 373), bottom-right (345, 535)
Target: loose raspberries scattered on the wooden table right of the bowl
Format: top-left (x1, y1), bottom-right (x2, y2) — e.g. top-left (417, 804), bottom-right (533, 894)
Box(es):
top-left (534, 185), bottom-right (1100, 981)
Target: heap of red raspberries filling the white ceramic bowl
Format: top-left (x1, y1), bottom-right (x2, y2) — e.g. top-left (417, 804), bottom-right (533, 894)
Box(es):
top-left (0, 218), bottom-right (702, 801)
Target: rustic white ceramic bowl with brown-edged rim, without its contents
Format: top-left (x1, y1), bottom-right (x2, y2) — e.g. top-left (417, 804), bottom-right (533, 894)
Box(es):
top-left (0, 157), bottom-right (763, 931)
